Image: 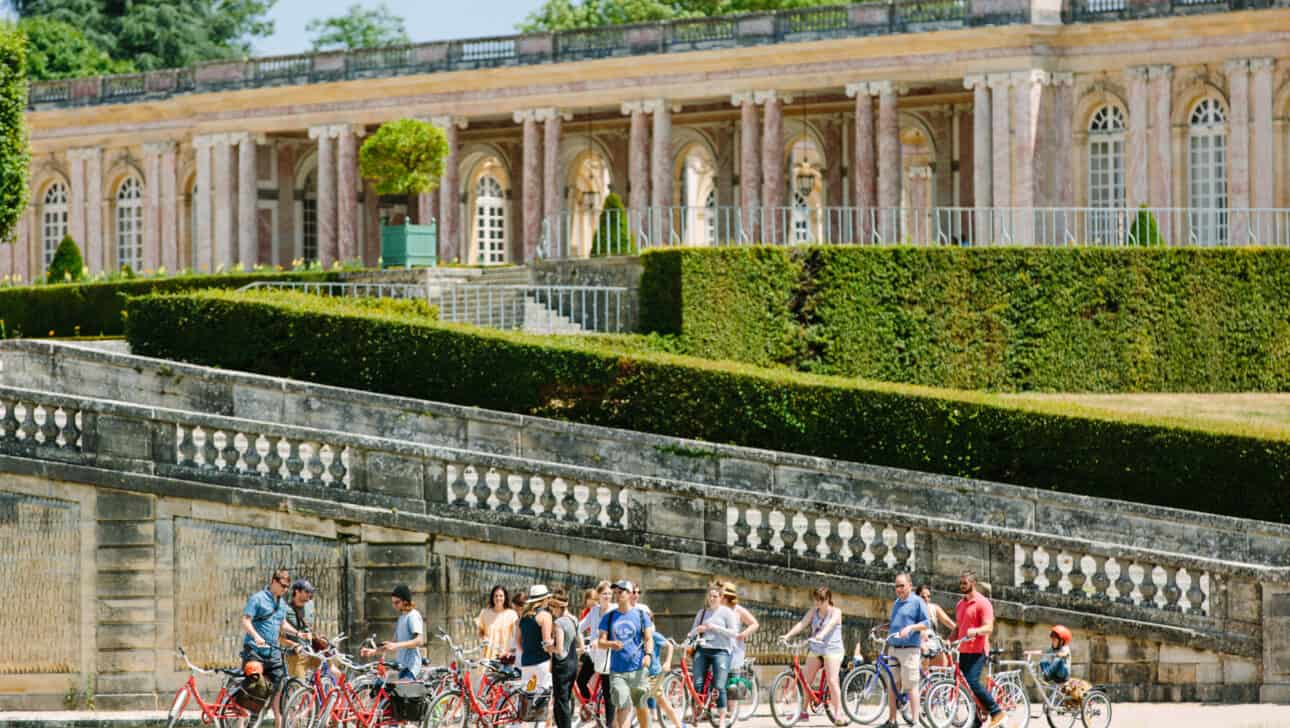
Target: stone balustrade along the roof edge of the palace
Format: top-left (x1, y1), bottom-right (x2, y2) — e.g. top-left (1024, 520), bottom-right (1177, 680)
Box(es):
top-left (28, 0), bottom-right (1282, 110)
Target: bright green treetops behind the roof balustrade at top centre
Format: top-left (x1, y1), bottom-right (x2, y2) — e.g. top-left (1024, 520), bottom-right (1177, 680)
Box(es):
top-left (517, 0), bottom-right (830, 32)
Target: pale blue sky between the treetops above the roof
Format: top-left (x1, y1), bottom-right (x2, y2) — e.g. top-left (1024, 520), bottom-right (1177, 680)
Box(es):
top-left (255, 0), bottom-right (541, 56)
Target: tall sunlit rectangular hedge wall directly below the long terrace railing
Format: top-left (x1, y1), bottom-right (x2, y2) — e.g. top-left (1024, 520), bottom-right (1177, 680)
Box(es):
top-left (641, 247), bottom-right (1290, 392)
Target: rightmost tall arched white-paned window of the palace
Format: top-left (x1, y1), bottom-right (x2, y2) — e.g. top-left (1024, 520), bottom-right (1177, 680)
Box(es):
top-left (1187, 97), bottom-right (1228, 245)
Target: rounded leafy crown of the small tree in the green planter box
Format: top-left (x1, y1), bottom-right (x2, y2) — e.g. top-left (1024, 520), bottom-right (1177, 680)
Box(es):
top-left (359, 119), bottom-right (448, 195)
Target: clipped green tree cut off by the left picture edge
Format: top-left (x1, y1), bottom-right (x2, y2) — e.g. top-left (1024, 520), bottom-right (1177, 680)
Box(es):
top-left (0, 23), bottom-right (31, 241)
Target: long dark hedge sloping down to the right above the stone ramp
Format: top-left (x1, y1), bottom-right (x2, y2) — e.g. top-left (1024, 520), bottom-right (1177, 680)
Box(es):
top-left (126, 290), bottom-right (1290, 523)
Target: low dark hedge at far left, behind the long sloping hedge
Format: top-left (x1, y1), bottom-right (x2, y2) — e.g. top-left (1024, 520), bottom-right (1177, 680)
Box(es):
top-left (0, 271), bottom-right (338, 338)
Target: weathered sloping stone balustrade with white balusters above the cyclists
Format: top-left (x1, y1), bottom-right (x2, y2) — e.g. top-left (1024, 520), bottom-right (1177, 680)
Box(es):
top-left (0, 386), bottom-right (1274, 656)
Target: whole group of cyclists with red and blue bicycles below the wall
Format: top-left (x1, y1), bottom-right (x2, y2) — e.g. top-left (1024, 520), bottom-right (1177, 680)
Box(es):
top-left (179, 569), bottom-right (1109, 728)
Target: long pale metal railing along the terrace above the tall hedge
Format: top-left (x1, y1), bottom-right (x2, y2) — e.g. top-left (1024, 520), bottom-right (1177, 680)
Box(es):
top-left (538, 207), bottom-right (1290, 259)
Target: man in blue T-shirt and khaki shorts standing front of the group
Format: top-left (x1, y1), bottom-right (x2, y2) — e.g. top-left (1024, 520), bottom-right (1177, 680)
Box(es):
top-left (597, 580), bottom-right (654, 728)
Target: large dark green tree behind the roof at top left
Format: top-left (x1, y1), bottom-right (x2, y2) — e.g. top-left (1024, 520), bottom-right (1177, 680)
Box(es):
top-left (8, 0), bottom-right (276, 71)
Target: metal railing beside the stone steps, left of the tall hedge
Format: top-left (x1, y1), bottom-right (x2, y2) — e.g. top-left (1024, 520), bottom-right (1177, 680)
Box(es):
top-left (241, 281), bottom-right (635, 334)
